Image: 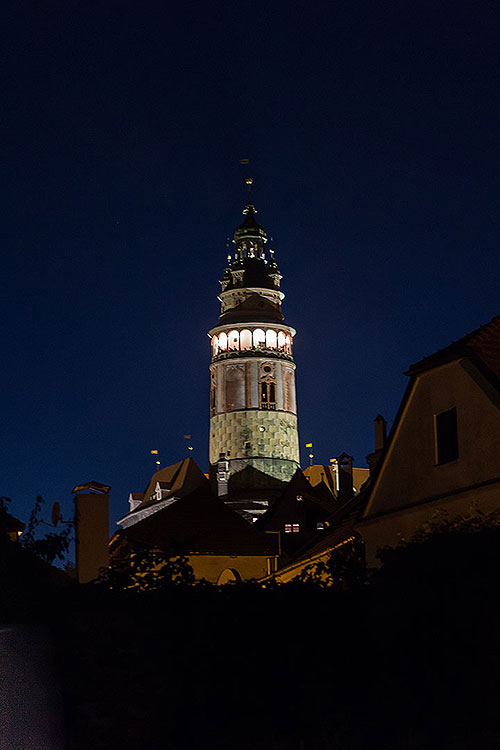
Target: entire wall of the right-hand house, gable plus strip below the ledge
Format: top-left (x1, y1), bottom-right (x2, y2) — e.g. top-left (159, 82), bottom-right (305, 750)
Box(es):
top-left (357, 359), bottom-right (500, 564)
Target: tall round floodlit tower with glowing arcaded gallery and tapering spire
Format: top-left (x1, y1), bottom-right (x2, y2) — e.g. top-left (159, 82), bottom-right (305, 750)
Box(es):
top-left (209, 180), bottom-right (300, 495)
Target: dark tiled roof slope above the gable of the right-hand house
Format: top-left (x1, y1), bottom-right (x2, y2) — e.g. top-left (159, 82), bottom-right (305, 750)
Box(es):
top-left (405, 315), bottom-right (500, 378)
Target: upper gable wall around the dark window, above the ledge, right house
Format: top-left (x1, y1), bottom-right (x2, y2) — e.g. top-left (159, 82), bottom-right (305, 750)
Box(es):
top-left (365, 360), bottom-right (500, 516)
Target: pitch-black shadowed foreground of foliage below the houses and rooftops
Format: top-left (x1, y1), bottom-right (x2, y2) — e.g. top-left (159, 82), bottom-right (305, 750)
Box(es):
top-left (0, 529), bottom-right (500, 750)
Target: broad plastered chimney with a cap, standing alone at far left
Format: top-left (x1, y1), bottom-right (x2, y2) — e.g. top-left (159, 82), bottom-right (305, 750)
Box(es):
top-left (73, 482), bottom-right (111, 583)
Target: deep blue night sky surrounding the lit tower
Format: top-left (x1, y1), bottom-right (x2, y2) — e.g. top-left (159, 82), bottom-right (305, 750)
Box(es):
top-left (0, 0), bottom-right (500, 521)
